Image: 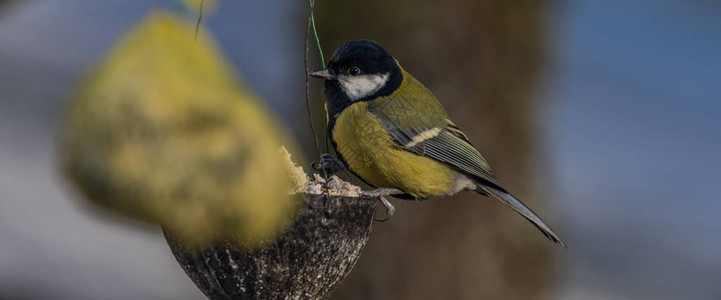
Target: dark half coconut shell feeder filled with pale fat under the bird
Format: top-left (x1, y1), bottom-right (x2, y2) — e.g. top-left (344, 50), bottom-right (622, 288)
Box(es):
top-left (164, 172), bottom-right (388, 300)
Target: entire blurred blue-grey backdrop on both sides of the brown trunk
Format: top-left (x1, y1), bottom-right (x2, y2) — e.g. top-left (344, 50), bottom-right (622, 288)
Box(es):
top-left (0, 0), bottom-right (721, 299)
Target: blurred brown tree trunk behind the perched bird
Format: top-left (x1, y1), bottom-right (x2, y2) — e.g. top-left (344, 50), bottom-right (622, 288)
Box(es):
top-left (316, 0), bottom-right (558, 299)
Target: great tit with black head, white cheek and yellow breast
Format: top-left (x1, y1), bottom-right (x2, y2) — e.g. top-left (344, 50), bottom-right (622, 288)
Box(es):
top-left (310, 40), bottom-right (565, 247)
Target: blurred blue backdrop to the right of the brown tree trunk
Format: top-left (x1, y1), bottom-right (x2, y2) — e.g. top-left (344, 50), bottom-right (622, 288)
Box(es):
top-left (545, 0), bottom-right (721, 299)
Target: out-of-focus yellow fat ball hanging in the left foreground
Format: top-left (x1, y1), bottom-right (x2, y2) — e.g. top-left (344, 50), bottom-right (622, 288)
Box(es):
top-left (61, 12), bottom-right (297, 245)
